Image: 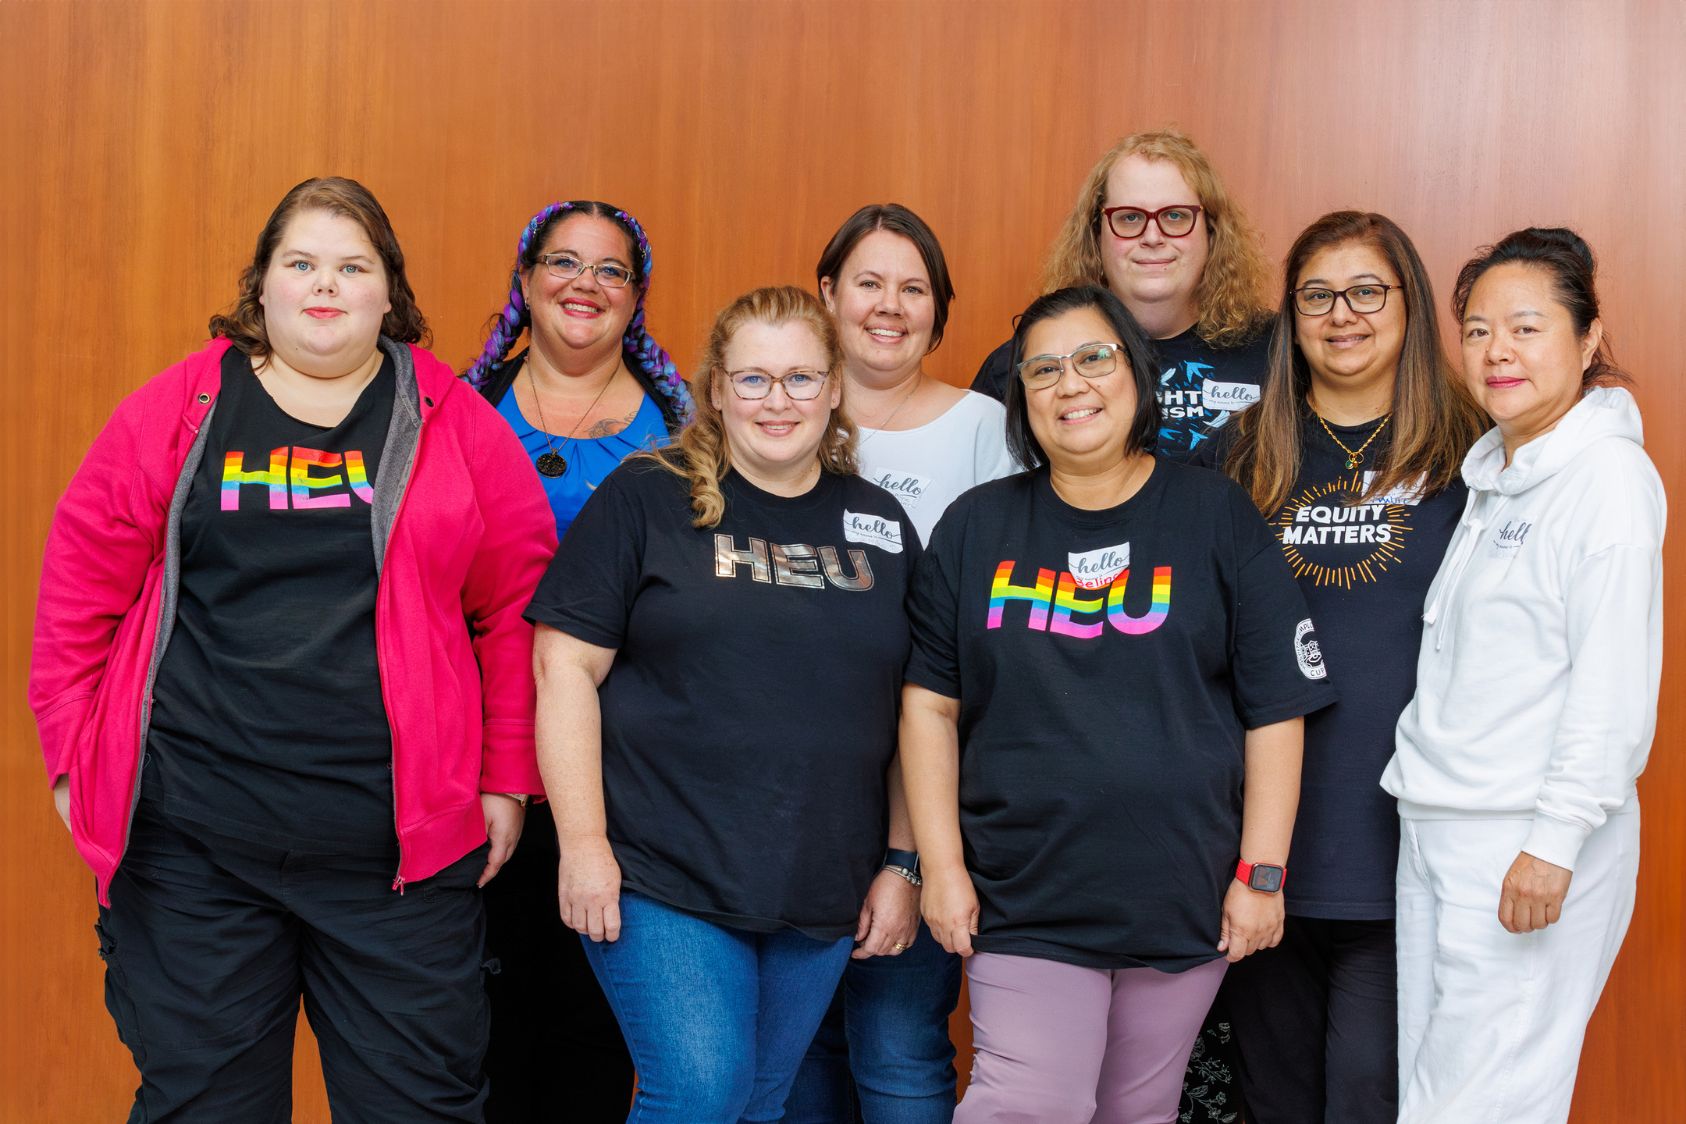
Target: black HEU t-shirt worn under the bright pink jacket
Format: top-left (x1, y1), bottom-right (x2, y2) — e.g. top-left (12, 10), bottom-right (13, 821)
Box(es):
top-left (142, 347), bottom-right (398, 856)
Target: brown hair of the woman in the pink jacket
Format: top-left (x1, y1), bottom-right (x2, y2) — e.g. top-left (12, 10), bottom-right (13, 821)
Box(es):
top-left (211, 175), bottom-right (428, 359)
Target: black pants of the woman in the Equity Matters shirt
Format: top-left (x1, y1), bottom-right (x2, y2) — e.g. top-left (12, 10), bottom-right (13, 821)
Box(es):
top-left (1222, 915), bottom-right (1399, 1124)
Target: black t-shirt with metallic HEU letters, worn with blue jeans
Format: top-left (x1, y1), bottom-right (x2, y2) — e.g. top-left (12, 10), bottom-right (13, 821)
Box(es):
top-left (528, 457), bottom-right (921, 940)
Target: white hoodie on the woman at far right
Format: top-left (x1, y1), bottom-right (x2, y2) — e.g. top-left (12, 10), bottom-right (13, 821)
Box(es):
top-left (1381, 388), bottom-right (1667, 870)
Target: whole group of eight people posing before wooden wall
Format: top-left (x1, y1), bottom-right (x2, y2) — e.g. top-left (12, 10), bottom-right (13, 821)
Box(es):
top-left (30, 123), bottom-right (1664, 1124)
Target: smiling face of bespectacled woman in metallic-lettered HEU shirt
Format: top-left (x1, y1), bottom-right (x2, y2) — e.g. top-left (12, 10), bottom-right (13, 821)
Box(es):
top-left (708, 320), bottom-right (841, 492)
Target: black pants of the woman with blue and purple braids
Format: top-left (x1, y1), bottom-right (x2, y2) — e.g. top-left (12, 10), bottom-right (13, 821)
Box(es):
top-left (486, 804), bottom-right (632, 1124)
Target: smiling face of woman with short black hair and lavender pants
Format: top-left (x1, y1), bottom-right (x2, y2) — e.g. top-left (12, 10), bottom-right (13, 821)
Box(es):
top-left (1015, 308), bottom-right (1136, 472)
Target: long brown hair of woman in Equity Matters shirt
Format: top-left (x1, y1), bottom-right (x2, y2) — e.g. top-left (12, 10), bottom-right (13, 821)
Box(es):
top-left (1224, 211), bottom-right (1485, 517)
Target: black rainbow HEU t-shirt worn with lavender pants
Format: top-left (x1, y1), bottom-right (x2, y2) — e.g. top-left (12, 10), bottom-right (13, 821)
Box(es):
top-left (907, 460), bottom-right (1334, 971)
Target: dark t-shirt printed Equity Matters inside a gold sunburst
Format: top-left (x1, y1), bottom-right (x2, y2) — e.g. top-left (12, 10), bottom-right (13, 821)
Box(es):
top-left (1200, 409), bottom-right (1469, 920)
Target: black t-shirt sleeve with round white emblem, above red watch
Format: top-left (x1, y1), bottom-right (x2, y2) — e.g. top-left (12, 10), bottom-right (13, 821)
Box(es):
top-left (1227, 485), bottom-right (1335, 730)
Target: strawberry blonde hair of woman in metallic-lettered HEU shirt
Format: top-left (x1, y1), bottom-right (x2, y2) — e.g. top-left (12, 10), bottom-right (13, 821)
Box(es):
top-left (649, 285), bottom-right (858, 529)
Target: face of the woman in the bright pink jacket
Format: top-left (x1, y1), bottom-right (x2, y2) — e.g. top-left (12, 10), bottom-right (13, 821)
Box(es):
top-left (258, 211), bottom-right (393, 379)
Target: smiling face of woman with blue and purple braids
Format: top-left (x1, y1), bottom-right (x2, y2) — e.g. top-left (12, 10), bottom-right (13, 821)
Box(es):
top-left (521, 214), bottom-right (639, 369)
